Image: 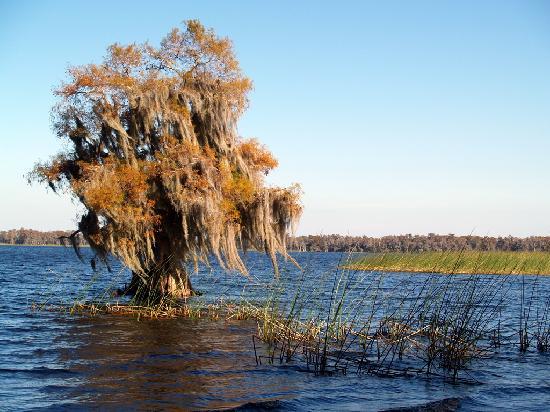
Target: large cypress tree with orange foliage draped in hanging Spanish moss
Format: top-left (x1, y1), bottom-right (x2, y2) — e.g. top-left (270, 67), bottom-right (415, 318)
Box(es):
top-left (33, 20), bottom-right (302, 296)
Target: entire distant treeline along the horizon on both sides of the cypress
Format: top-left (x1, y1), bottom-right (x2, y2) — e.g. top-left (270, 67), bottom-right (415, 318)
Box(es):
top-left (0, 228), bottom-right (550, 252)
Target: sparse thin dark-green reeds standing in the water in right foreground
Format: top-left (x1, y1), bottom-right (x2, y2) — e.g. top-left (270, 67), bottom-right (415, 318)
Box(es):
top-left (254, 253), bottom-right (550, 382)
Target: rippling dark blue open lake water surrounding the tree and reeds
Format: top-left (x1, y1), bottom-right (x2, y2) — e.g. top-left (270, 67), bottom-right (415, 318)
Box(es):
top-left (0, 246), bottom-right (550, 411)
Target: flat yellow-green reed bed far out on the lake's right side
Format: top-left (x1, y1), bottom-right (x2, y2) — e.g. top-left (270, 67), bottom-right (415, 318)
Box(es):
top-left (347, 251), bottom-right (550, 275)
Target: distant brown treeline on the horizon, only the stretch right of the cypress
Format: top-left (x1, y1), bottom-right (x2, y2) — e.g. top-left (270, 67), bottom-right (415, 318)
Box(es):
top-left (288, 233), bottom-right (550, 253)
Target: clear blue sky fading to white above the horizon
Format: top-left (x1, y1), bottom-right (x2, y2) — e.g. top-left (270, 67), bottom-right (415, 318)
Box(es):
top-left (0, 0), bottom-right (550, 236)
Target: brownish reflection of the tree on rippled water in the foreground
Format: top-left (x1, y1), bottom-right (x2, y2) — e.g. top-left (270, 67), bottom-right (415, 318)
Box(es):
top-left (58, 316), bottom-right (300, 409)
